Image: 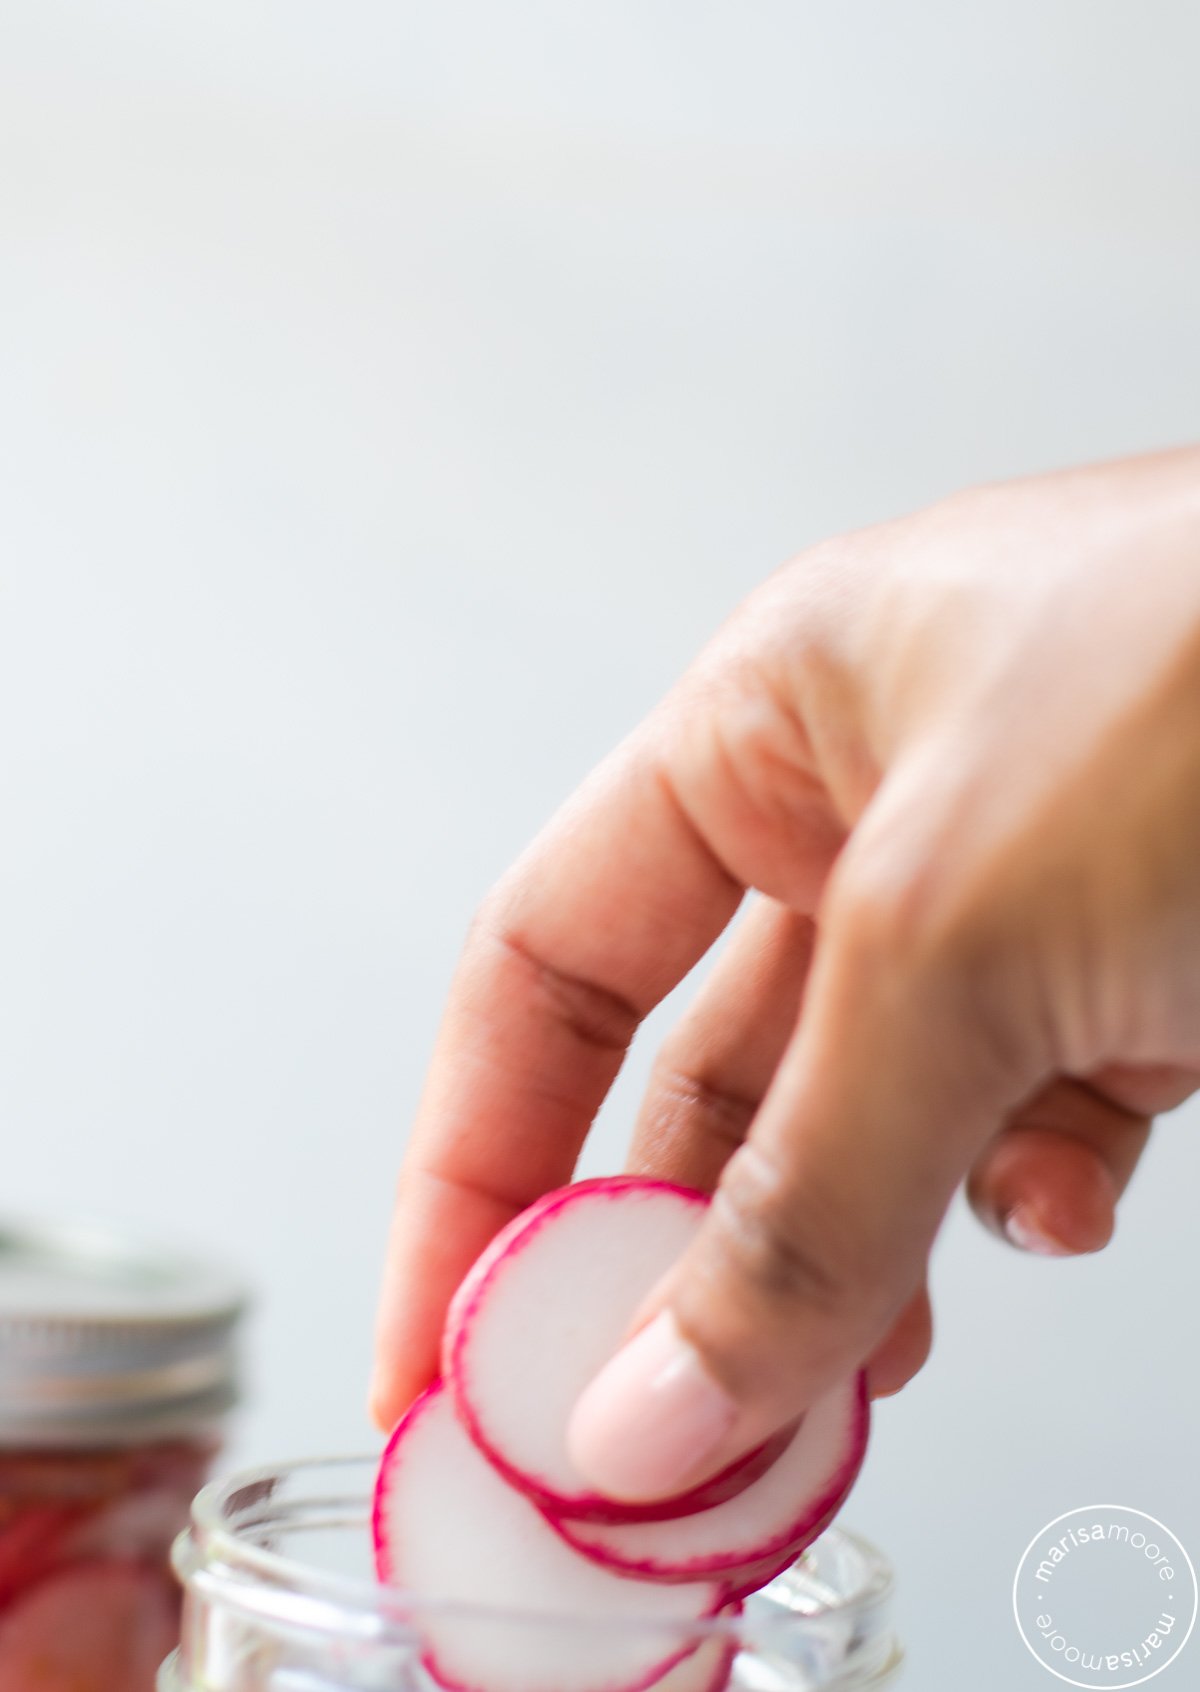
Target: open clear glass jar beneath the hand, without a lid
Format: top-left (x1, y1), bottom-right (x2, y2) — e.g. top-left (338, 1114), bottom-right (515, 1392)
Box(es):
top-left (156, 1459), bottom-right (900, 1692)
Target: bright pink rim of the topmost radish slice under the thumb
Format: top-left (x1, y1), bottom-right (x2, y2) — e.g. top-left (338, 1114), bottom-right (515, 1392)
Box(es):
top-left (442, 1174), bottom-right (787, 1526)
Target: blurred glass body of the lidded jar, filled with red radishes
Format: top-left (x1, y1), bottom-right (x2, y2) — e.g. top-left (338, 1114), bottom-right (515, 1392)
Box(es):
top-left (0, 1437), bottom-right (213, 1692)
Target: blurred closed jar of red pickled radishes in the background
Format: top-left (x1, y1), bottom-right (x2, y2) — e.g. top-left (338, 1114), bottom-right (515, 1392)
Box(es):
top-left (0, 1222), bottom-right (244, 1692)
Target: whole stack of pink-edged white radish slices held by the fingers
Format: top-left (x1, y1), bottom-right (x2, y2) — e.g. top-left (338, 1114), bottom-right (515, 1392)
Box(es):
top-left (374, 1178), bottom-right (868, 1692)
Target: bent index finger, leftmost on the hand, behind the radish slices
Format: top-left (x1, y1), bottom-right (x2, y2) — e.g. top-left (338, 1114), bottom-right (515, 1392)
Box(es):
top-left (372, 729), bottom-right (743, 1426)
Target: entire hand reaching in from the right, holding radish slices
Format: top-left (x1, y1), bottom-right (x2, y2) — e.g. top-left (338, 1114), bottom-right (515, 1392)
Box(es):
top-left (374, 450), bottom-right (1200, 1497)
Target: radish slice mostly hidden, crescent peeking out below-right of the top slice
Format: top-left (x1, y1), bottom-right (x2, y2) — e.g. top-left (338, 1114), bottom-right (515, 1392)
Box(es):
top-left (547, 1376), bottom-right (870, 1590)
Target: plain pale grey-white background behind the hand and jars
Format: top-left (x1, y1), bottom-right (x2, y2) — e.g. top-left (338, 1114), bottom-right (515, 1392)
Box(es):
top-left (0, 0), bottom-right (1200, 1692)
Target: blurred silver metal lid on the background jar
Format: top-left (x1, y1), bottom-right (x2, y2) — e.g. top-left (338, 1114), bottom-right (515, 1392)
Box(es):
top-left (0, 1218), bottom-right (245, 1448)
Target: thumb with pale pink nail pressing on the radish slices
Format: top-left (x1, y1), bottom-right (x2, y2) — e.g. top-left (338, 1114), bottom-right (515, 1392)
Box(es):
top-left (570, 863), bottom-right (1032, 1499)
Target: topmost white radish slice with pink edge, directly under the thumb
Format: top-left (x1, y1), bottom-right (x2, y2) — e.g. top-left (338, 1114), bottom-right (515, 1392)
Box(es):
top-left (442, 1176), bottom-right (789, 1523)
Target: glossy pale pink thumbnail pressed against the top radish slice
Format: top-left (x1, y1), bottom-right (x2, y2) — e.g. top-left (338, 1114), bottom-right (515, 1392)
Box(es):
top-left (567, 1310), bottom-right (738, 1501)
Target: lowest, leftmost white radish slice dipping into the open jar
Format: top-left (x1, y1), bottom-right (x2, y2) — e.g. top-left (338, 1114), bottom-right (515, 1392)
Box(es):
top-left (374, 1386), bottom-right (724, 1692)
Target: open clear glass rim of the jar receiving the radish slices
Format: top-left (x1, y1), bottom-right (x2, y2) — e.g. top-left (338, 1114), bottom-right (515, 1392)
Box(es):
top-left (173, 1457), bottom-right (897, 1651)
